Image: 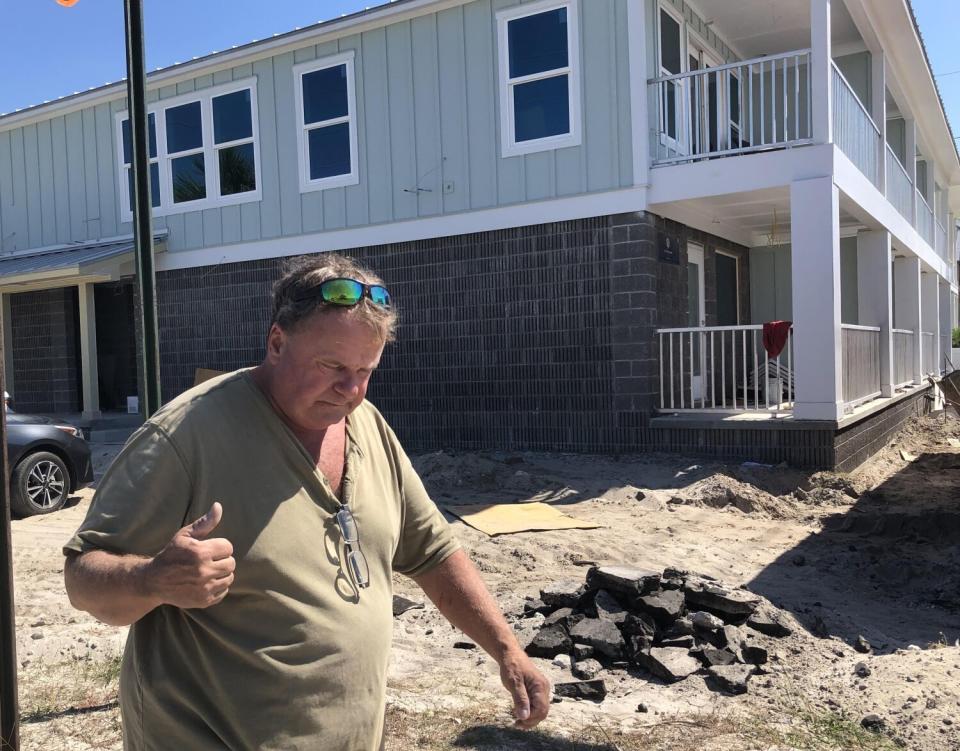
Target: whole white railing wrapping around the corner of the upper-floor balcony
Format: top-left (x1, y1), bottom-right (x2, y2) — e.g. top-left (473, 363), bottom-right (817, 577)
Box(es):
top-left (648, 49), bottom-right (952, 267)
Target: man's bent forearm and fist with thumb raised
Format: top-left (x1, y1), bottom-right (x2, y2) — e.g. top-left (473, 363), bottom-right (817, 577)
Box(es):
top-left (63, 503), bottom-right (236, 626)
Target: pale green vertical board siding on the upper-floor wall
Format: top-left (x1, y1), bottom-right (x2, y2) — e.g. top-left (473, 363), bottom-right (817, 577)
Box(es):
top-left (0, 0), bottom-right (636, 252)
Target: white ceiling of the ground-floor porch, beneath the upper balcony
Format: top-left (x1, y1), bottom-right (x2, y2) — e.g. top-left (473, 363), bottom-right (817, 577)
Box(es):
top-left (651, 187), bottom-right (863, 246)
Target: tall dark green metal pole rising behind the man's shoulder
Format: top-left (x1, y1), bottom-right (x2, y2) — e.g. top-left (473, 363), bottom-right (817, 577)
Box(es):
top-left (123, 0), bottom-right (160, 417)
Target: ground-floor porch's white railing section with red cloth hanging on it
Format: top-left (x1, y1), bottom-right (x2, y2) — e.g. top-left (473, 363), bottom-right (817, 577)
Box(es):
top-left (657, 325), bottom-right (794, 412)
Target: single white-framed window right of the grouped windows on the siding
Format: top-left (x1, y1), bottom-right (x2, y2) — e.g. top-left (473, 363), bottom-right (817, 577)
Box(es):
top-left (293, 52), bottom-right (360, 192)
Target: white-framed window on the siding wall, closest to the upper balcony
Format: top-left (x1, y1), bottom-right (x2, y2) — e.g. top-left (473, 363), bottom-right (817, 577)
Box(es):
top-left (497, 0), bottom-right (580, 157)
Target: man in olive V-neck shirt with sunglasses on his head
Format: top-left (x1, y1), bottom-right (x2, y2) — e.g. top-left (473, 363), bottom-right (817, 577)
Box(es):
top-left (64, 254), bottom-right (550, 751)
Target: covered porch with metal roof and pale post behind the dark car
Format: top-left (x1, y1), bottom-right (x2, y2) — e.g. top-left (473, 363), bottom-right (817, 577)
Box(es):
top-left (0, 233), bottom-right (165, 422)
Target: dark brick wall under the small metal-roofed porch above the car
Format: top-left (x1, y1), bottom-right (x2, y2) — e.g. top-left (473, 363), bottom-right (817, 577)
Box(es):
top-left (10, 287), bottom-right (82, 412)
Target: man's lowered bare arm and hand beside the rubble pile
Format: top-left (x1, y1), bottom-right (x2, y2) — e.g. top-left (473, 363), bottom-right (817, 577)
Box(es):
top-left (414, 550), bottom-right (550, 728)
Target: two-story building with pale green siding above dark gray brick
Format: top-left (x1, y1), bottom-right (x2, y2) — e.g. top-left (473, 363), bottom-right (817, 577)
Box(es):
top-left (0, 0), bottom-right (960, 468)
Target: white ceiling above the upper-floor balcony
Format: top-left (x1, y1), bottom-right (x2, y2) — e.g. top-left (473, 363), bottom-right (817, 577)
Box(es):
top-left (693, 0), bottom-right (860, 58)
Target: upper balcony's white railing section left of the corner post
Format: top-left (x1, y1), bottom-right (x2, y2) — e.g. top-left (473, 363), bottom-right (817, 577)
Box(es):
top-left (649, 49), bottom-right (812, 164)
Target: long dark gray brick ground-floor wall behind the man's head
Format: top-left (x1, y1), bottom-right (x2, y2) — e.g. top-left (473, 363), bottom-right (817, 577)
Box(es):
top-left (158, 212), bottom-right (749, 451)
